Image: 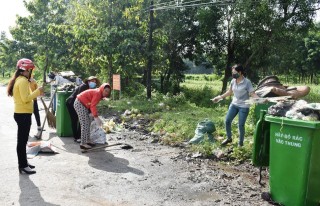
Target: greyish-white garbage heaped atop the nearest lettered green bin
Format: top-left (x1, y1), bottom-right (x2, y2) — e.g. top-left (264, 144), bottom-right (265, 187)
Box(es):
top-left (268, 100), bottom-right (320, 121)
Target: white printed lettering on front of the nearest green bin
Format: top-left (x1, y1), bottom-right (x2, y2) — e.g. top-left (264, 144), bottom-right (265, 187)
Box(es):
top-left (274, 132), bottom-right (303, 148)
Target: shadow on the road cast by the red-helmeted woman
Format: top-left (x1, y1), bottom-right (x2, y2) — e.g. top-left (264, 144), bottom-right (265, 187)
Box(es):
top-left (19, 175), bottom-right (59, 206)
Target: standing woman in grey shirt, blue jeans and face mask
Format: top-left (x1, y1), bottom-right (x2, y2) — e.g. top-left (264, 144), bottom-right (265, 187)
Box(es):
top-left (212, 64), bottom-right (258, 147)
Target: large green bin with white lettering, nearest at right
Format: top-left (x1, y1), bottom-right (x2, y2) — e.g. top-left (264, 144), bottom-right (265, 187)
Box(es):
top-left (265, 115), bottom-right (320, 206)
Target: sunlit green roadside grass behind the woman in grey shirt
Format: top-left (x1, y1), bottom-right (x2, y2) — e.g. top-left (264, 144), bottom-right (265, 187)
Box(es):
top-left (102, 75), bottom-right (320, 162)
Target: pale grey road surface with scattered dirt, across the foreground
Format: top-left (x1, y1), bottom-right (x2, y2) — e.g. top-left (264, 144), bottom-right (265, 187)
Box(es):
top-left (0, 86), bottom-right (269, 206)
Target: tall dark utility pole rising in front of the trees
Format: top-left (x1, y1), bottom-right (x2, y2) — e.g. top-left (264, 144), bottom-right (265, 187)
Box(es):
top-left (147, 1), bottom-right (153, 99)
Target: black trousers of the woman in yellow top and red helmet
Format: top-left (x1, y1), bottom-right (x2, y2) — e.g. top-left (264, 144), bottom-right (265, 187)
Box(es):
top-left (13, 113), bottom-right (32, 168)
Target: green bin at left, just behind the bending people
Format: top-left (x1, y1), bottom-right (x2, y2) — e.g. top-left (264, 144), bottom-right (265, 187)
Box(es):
top-left (56, 91), bottom-right (73, 137)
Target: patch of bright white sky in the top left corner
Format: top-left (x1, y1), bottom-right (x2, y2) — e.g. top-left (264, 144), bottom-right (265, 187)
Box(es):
top-left (0, 0), bottom-right (28, 37)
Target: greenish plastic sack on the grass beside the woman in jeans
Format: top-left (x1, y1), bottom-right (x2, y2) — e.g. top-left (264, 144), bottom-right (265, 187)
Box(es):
top-left (189, 119), bottom-right (216, 144)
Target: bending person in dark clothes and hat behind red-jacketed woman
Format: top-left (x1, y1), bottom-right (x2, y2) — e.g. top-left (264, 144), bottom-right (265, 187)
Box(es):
top-left (66, 76), bottom-right (100, 143)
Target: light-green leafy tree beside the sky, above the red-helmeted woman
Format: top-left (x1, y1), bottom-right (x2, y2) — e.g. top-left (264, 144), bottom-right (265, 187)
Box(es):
top-left (11, 0), bottom-right (66, 82)
